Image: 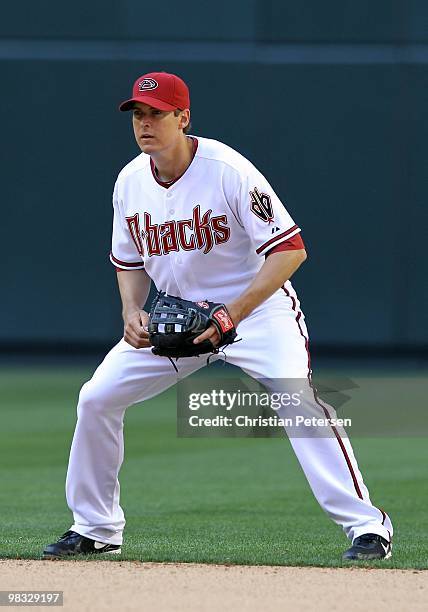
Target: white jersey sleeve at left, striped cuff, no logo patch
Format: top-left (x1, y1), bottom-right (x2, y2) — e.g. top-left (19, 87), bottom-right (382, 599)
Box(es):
top-left (110, 183), bottom-right (144, 270)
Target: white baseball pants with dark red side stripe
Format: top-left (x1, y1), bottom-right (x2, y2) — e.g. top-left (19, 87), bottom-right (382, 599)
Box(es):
top-left (66, 290), bottom-right (392, 544)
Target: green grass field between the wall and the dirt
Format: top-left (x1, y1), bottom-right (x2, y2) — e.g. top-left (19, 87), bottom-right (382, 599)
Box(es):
top-left (0, 366), bottom-right (428, 568)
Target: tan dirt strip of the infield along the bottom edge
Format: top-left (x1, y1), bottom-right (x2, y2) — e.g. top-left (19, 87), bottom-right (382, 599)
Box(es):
top-left (0, 560), bottom-right (428, 612)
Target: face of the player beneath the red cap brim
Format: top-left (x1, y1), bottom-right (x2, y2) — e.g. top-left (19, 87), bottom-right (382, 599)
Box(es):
top-left (132, 102), bottom-right (189, 155)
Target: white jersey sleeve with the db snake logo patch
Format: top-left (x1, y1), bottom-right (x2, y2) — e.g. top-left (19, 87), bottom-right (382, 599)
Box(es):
top-left (231, 164), bottom-right (300, 256)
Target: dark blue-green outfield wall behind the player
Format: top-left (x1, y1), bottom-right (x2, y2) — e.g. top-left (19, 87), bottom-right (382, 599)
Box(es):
top-left (0, 0), bottom-right (428, 347)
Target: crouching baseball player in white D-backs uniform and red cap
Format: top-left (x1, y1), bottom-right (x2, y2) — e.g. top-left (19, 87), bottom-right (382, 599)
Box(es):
top-left (43, 72), bottom-right (392, 560)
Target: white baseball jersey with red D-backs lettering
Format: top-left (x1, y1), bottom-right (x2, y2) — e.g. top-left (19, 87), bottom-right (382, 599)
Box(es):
top-left (110, 138), bottom-right (300, 302)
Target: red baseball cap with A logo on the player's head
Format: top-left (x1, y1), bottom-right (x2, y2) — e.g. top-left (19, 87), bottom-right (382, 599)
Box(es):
top-left (119, 72), bottom-right (190, 111)
